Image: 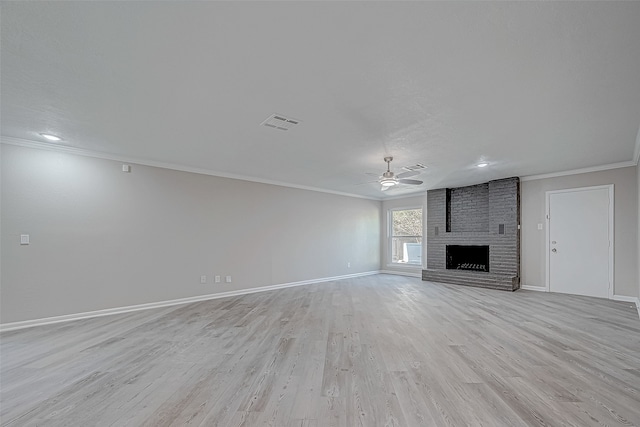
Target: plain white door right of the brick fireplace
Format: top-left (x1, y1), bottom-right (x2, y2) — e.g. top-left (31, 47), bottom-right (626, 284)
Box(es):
top-left (547, 186), bottom-right (613, 298)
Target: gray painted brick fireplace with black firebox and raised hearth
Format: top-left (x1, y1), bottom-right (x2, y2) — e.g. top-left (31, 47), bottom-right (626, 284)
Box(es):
top-left (422, 177), bottom-right (520, 291)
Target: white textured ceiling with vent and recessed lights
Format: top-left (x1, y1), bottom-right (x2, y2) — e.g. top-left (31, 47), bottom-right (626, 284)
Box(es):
top-left (1, 2), bottom-right (640, 197)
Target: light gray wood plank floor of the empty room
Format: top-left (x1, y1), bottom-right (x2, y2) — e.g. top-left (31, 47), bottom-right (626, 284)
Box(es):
top-left (0, 275), bottom-right (640, 427)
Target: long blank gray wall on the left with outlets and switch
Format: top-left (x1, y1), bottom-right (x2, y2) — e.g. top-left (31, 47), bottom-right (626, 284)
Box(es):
top-left (0, 144), bottom-right (381, 323)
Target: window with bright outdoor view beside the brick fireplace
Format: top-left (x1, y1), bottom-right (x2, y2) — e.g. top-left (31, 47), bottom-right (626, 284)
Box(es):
top-left (389, 208), bottom-right (422, 266)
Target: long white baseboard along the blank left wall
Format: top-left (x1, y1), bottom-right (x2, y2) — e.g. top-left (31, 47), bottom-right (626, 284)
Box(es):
top-left (0, 270), bottom-right (380, 332)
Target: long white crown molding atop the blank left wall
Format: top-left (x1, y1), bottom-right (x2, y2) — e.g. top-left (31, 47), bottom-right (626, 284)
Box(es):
top-left (0, 135), bottom-right (382, 202)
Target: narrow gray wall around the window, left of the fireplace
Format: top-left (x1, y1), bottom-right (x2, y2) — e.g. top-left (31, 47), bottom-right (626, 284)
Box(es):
top-left (380, 192), bottom-right (427, 277)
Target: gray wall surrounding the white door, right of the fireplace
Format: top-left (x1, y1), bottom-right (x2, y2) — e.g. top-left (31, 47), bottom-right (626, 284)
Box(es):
top-left (520, 167), bottom-right (640, 297)
